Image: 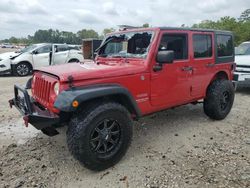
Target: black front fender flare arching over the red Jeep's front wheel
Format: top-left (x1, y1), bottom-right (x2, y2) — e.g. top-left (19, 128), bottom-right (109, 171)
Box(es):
top-left (54, 85), bottom-right (141, 118)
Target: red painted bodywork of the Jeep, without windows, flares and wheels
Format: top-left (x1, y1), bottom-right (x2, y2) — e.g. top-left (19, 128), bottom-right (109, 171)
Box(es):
top-left (32, 28), bottom-right (233, 115)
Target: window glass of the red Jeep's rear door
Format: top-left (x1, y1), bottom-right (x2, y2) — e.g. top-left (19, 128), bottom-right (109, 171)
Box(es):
top-left (193, 34), bottom-right (212, 58)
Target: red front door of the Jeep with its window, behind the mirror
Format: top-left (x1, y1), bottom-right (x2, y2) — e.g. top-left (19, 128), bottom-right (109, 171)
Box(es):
top-left (151, 31), bottom-right (192, 108)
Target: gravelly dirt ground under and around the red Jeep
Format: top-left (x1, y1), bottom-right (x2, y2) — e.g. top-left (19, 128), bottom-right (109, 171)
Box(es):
top-left (0, 49), bottom-right (250, 188)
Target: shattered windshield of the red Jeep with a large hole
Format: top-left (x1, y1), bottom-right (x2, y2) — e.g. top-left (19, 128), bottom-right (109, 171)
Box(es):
top-left (98, 31), bottom-right (153, 58)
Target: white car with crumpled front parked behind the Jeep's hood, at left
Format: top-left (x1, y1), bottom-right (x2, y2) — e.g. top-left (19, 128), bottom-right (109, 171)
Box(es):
top-left (0, 43), bottom-right (83, 76)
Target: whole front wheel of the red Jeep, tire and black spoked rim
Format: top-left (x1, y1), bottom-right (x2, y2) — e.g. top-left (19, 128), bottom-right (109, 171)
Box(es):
top-left (67, 103), bottom-right (132, 171)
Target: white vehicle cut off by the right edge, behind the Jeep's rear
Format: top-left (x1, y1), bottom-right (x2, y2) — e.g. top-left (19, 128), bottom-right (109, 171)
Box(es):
top-left (234, 41), bottom-right (250, 86)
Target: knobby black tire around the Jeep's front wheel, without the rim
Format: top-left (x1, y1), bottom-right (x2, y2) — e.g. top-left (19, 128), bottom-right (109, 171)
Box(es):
top-left (67, 102), bottom-right (133, 171)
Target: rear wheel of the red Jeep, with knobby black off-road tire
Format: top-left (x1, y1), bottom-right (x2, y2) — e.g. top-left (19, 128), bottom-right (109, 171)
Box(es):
top-left (203, 80), bottom-right (235, 120)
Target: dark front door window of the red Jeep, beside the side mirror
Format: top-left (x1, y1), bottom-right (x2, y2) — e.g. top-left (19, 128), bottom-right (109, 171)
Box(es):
top-left (159, 33), bottom-right (188, 60)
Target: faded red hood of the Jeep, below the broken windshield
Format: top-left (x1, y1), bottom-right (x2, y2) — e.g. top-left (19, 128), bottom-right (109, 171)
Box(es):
top-left (38, 60), bottom-right (146, 81)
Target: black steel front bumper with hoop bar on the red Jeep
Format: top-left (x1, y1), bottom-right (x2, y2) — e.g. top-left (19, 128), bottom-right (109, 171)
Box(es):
top-left (9, 85), bottom-right (59, 136)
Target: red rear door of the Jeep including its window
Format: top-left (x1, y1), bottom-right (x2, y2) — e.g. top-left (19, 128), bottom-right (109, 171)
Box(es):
top-left (191, 32), bottom-right (215, 98)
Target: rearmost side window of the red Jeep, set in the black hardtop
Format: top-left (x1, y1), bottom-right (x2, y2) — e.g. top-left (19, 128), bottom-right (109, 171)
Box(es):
top-left (217, 35), bottom-right (234, 57)
